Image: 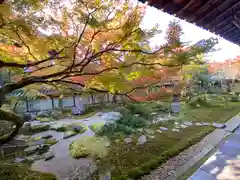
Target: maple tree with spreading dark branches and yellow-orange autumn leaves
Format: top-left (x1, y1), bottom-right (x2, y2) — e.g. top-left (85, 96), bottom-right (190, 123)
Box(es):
top-left (0, 0), bottom-right (218, 145)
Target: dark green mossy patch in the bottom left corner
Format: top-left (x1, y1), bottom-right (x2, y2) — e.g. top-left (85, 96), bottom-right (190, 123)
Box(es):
top-left (0, 163), bottom-right (57, 180)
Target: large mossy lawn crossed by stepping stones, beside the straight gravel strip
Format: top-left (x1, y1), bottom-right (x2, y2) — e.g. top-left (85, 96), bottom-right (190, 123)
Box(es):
top-left (94, 99), bottom-right (240, 180)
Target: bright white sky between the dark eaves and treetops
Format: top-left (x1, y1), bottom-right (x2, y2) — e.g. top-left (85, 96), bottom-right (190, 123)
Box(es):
top-left (142, 6), bottom-right (240, 62)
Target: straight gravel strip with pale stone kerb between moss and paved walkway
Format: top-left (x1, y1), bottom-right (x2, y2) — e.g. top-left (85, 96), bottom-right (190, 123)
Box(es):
top-left (141, 114), bottom-right (240, 180)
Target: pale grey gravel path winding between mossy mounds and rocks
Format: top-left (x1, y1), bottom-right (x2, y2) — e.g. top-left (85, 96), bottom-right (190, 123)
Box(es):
top-left (32, 116), bottom-right (109, 180)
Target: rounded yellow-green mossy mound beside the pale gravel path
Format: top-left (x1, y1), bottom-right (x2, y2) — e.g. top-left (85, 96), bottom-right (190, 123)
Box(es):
top-left (69, 136), bottom-right (109, 158)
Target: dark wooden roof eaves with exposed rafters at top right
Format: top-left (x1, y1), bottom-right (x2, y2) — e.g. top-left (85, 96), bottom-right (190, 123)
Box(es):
top-left (139, 0), bottom-right (240, 45)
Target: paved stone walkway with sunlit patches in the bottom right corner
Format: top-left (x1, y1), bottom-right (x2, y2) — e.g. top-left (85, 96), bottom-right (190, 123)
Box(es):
top-left (188, 124), bottom-right (240, 180)
